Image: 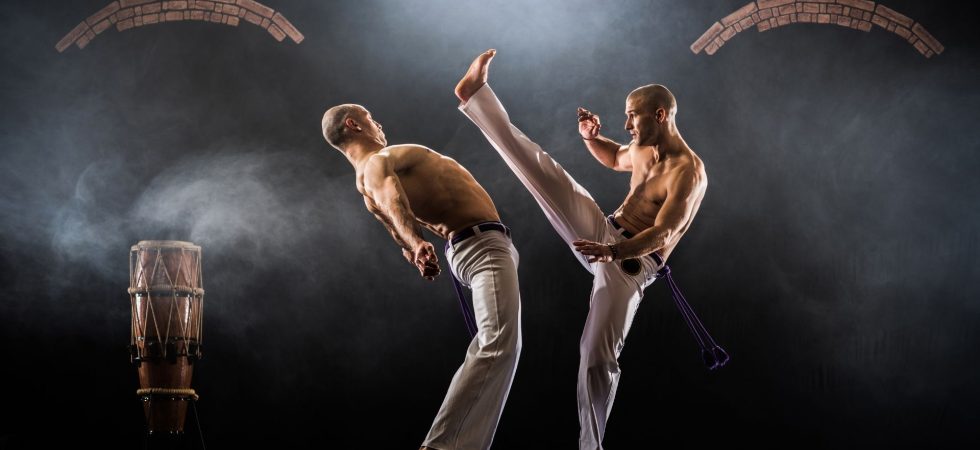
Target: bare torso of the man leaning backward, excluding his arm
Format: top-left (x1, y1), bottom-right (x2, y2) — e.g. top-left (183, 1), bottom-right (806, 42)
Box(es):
top-left (356, 144), bottom-right (500, 239)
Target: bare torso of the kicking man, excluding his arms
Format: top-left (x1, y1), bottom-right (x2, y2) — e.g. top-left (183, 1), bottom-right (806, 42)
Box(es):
top-left (614, 146), bottom-right (707, 259)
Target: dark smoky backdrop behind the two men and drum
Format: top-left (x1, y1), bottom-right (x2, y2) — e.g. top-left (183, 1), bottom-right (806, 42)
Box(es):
top-left (0, 0), bottom-right (980, 449)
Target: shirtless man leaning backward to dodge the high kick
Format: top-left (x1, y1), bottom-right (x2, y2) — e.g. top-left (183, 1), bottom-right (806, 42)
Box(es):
top-left (321, 104), bottom-right (521, 450)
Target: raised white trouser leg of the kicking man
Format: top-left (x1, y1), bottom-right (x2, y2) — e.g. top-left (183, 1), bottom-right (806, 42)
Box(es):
top-left (459, 84), bottom-right (608, 272)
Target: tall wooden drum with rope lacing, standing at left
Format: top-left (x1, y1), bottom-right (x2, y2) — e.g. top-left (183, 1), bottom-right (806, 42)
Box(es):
top-left (129, 241), bottom-right (204, 434)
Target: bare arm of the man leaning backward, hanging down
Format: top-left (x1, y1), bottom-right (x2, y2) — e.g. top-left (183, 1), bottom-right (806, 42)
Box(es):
top-left (364, 155), bottom-right (439, 280)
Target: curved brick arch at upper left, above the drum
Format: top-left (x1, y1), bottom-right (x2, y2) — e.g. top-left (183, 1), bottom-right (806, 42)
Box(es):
top-left (55, 0), bottom-right (303, 53)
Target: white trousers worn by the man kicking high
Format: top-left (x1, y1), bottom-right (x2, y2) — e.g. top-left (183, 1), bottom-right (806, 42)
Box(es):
top-left (459, 85), bottom-right (662, 449)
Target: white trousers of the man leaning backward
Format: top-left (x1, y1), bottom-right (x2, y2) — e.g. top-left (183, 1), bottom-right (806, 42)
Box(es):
top-left (423, 230), bottom-right (521, 450)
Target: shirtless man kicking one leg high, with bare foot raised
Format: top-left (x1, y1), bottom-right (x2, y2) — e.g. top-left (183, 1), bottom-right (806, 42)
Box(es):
top-left (456, 50), bottom-right (708, 449)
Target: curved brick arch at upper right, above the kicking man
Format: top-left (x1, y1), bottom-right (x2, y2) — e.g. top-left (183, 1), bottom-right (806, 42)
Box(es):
top-left (691, 0), bottom-right (944, 58)
